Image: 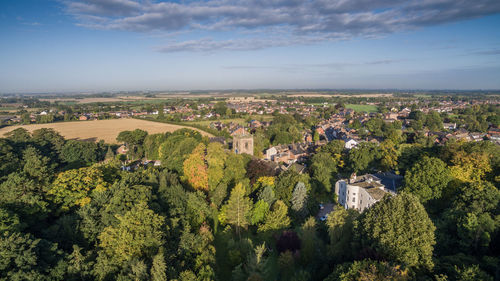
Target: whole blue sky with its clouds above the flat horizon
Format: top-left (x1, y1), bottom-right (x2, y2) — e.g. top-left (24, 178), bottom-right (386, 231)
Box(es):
top-left (0, 0), bottom-right (500, 93)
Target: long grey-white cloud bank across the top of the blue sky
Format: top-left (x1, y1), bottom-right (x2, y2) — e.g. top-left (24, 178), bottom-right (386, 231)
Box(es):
top-left (64, 0), bottom-right (500, 52)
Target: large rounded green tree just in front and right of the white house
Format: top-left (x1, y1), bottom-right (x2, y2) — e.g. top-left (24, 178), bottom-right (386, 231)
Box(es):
top-left (360, 193), bottom-right (436, 269)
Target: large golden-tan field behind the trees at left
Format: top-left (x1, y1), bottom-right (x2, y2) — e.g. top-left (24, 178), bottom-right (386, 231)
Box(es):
top-left (0, 119), bottom-right (212, 143)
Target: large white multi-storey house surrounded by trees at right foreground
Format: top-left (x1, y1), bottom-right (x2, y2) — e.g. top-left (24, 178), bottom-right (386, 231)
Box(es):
top-left (335, 174), bottom-right (395, 212)
